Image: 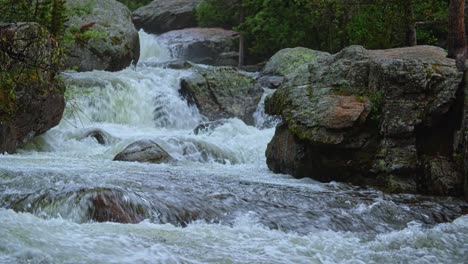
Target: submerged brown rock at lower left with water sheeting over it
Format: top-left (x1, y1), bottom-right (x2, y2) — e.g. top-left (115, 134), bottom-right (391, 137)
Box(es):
top-left (5, 187), bottom-right (149, 224)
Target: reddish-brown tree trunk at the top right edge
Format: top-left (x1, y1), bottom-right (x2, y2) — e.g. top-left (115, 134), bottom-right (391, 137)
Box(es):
top-left (447, 0), bottom-right (466, 70)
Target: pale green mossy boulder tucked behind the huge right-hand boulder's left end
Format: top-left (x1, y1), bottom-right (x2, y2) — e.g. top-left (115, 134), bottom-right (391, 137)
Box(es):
top-left (258, 47), bottom-right (330, 89)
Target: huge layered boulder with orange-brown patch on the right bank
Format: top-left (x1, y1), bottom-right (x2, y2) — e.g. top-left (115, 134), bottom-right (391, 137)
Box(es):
top-left (265, 46), bottom-right (464, 195)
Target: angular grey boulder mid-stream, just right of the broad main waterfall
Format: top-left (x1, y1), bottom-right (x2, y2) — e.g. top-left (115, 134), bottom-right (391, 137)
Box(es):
top-left (180, 66), bottom-right (263, 125)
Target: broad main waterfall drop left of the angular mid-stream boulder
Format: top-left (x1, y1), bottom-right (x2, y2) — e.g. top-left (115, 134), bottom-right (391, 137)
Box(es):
top-left (66, 67), bottom-right (201, 128)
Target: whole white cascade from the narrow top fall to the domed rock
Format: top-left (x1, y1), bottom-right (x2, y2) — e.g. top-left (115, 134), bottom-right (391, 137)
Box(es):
top-left (25, 31), bottom-right (277, 166)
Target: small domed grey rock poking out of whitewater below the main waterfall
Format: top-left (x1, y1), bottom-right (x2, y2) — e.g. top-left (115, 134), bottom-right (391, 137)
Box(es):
top-left (114, 140), bottom-right (175, 163)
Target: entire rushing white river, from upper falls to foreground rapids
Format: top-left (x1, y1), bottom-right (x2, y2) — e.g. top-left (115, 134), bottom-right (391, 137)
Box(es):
top-left (0, 33), bottom-right (468, 263)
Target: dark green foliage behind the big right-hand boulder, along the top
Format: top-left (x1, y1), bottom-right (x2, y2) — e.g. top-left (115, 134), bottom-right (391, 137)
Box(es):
top-left (197, 0), bottom-right (448, 57)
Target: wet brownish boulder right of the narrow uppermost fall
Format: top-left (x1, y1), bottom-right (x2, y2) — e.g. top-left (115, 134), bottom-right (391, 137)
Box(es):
top-left (158, 28), bottom-right (239, 66)
